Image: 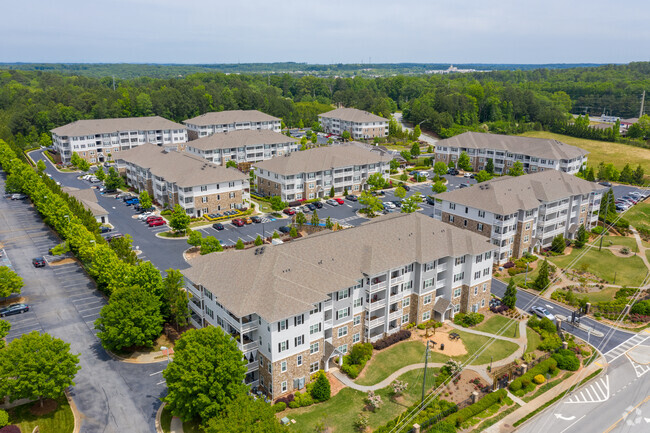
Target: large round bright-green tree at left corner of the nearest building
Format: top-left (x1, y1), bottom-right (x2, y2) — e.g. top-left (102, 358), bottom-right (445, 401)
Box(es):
top-left (163, 326), bottom-right (246, 421)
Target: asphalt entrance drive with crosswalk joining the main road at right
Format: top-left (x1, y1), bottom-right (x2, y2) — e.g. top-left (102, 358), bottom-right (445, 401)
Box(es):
top-left (492, 278), bottom-right (636, 353)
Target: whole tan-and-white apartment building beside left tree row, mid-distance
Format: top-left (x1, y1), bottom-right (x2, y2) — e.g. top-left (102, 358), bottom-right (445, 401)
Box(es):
top-left (117, 143), bottom-right (250, 217)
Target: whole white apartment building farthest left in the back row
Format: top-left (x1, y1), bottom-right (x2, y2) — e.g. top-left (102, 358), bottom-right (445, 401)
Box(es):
top-left (51, 116), bottom-right (187, 164)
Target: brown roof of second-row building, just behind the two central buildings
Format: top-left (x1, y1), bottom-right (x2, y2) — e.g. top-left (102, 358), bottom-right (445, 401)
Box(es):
top-left (187, 129), bottom-right (298, 150)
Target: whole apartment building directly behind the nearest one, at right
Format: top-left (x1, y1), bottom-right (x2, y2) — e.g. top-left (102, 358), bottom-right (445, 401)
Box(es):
top-left (434, 170), bottom-right (603, 264)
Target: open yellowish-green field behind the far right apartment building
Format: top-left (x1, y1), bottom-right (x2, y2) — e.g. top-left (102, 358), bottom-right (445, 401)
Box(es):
top-left (521, 131), bottom-right (650, 176)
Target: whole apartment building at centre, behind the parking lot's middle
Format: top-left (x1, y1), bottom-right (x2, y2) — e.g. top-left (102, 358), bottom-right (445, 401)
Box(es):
top-left (254, 144), bottom-right (391, 201)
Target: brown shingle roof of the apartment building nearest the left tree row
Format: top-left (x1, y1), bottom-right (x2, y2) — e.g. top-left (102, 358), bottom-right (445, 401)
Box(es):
top-left (116, 143), bottom-right (248, 187)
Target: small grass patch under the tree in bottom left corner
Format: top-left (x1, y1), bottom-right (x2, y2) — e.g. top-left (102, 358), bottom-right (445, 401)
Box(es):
top-left (8, 397), bottom-right (74, 433)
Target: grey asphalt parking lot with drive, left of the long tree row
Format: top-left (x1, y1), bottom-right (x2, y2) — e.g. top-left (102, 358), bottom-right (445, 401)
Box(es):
top-left (0, 173), bottom-right (166, 433)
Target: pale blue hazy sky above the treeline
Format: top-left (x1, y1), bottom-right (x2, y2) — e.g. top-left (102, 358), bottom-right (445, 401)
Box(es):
top-left (0, 0), bottom-right (650, 64)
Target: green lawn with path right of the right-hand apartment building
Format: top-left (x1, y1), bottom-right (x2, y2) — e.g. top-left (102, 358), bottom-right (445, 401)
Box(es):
top-left (550, 248), bottom-right (647, 287)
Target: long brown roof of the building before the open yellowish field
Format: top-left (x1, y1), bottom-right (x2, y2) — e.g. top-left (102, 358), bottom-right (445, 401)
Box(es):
top-left (436, 132), bottom-right (589, 160)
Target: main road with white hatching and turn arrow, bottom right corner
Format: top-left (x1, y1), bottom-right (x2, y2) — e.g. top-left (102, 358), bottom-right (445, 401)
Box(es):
top-left (519, 333), bottom-right (650, 433)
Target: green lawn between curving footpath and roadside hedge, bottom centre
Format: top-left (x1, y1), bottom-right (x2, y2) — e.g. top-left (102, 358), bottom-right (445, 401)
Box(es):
top-left (288, 368), bottom-right (438, 433)
